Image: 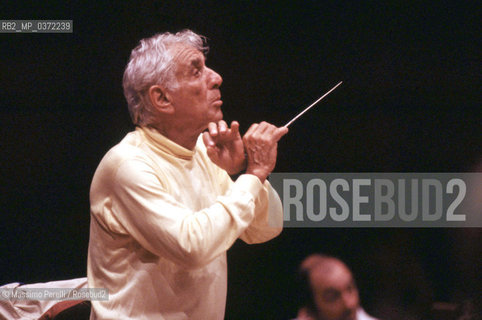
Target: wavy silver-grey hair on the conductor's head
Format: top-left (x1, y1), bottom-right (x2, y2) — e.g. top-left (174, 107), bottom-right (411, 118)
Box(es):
top-left (122, 29), bottom-right (209, 126)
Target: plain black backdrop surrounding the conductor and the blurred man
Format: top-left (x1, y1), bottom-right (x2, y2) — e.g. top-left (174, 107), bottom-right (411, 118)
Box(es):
top-left (0, 1), bottom-right (482, 319)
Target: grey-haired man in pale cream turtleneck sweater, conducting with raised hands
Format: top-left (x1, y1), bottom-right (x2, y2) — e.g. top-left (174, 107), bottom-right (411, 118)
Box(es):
top-left (87, 30), bottom-right (288, 320)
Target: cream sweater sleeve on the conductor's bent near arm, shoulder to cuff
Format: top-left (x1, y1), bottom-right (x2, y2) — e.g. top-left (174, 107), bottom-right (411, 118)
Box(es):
top-left (98, 160), bottom-right (264, 268)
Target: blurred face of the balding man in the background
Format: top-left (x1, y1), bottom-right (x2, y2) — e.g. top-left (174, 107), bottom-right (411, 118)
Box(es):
top-left (310, 263), bottom-right (359, 320)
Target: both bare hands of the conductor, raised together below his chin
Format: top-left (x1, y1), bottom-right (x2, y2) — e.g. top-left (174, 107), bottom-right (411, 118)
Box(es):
top-left (203, 120), bottom-right (288, 182)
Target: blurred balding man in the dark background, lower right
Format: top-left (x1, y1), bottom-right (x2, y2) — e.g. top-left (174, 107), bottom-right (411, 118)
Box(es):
top-left (296, 254), bottom-right (376, 320)
